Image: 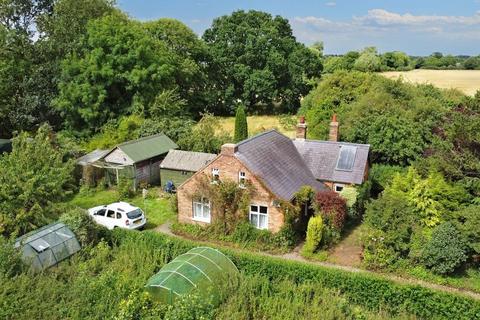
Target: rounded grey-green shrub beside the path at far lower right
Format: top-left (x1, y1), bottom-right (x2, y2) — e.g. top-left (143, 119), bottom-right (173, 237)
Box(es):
top-left (422, 222), bottom-right (467, 274)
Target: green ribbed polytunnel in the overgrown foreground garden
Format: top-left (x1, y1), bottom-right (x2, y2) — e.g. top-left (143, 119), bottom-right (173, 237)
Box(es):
top-left (146, 247), bottom-right (238, 303)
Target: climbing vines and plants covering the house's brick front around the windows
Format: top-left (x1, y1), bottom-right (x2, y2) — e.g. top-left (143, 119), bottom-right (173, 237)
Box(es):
top-left (172, 179), bottom-right (315, 252)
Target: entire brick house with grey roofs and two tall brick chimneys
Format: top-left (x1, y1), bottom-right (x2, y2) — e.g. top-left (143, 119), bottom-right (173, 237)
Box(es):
top-left (177, 116), bottom-right (369, 232)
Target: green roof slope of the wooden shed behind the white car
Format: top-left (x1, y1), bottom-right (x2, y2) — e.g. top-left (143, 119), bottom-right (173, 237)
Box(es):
top-left (117, 133), bottom-right (178, 163)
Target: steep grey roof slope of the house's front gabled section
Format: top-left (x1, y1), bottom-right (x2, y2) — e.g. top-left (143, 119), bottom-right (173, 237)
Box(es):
top-left (235, 130), bottom-right (327, 200)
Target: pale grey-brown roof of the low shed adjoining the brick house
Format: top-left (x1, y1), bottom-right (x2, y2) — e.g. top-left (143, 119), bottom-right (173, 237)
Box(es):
top-left (160, 150), bottom-right (217, 172)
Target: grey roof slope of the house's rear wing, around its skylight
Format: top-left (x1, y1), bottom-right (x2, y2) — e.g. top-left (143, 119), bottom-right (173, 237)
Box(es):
top-left (293, 139), bottom-right (370, 184)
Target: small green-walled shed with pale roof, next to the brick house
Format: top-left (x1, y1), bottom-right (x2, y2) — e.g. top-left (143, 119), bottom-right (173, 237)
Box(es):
top-left (160, 150), bottom-right (217, 187)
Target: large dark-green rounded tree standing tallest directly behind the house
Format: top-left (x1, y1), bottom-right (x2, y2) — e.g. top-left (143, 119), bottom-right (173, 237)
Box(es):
top-left (203, 10), bottom-right (322, 112)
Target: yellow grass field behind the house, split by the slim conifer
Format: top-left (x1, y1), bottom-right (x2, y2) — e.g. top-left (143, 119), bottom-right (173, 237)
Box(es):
top-left (218, 116), bottom-right (296, 138)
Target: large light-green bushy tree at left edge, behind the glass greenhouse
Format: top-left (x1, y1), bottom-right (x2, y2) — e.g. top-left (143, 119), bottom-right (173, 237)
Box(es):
top-left (0, 124), bottom-right (74, 236)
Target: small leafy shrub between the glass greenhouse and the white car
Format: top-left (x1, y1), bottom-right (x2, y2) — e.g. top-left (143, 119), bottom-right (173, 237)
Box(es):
top-left (60, 208), bottom-right (101, 247)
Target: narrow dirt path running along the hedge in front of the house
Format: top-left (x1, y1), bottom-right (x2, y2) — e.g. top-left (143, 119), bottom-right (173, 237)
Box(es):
top-left (154, 222), bottom-right (480, 300)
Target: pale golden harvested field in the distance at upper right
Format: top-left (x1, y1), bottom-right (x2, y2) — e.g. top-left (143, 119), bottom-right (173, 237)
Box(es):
top-left (382, 70), bottom-right (480, 95)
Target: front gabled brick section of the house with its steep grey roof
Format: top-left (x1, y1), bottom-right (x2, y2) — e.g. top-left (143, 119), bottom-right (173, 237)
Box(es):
top-left (177, 130), bottom-right (327, 232)
